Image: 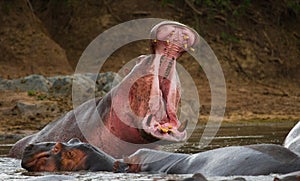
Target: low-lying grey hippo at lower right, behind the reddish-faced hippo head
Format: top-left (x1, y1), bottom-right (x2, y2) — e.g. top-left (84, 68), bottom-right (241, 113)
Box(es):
top-left (131, 144), bottom-right (300, 176)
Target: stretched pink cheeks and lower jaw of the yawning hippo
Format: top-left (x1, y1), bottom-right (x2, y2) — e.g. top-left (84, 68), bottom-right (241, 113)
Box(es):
top-left (142, 55), bottom-right (186, 141)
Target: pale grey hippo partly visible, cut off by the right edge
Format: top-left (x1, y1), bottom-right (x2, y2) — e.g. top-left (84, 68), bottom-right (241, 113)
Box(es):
top-left (283, 121), bottom-right (300, 156)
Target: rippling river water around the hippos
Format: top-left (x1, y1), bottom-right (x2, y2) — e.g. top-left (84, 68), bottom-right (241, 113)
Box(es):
top-left (0, 122), bottom-right (295, 181)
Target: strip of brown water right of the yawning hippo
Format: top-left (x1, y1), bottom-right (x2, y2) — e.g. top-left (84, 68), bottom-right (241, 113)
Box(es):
top-left (163, 122), bottom-right (297, 153)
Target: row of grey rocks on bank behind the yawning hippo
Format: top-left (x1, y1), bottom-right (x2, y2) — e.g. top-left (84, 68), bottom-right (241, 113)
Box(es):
top-left (0, 72), bottom-right (121, 98)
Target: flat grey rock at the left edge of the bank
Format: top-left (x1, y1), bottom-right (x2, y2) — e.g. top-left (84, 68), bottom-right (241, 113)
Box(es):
top-left (0, 74), bottom-right (51, 92)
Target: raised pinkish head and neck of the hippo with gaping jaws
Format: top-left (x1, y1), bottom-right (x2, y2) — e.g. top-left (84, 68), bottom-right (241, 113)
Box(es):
top-left (85, 21), bottom-right (199, 153)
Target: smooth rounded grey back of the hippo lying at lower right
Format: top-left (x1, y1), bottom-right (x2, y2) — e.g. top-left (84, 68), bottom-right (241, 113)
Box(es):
top-left (176, 144), bottom-right (300, 176)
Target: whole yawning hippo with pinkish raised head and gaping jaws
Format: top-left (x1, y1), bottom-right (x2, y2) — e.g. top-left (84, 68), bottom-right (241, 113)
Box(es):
top-left (8, 21), bottom-right (199, 158)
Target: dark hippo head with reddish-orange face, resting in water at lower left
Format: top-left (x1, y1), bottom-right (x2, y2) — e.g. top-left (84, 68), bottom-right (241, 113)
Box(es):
top-left (21, 138), bottom-right (114, 172)
